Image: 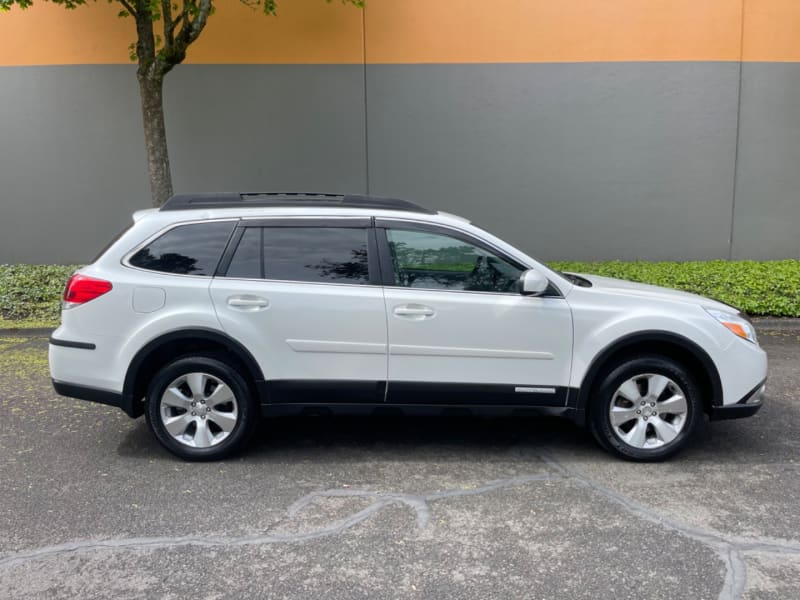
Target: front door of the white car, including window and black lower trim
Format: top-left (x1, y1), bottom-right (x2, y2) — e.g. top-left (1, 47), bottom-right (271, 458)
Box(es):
top-left (377, 220), bottom-right (572, 406)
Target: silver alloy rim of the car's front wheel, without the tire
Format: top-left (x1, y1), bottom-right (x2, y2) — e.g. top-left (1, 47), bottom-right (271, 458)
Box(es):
top-left (608, 373), bottom-right (689, 450)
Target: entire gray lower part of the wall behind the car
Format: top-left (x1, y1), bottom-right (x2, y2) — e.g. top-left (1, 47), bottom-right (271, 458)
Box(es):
top-left (0, 62), bottom-right (800, 263)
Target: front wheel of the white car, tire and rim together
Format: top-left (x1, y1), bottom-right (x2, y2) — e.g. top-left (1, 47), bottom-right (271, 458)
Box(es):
top-left (590, 356), bottom-right (701, 461)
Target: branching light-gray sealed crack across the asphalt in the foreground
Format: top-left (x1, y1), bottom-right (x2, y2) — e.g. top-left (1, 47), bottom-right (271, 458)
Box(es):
top-left (0, 454), bottom-right (800, 600)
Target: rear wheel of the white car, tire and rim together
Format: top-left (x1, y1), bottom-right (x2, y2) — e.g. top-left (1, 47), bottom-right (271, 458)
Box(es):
top-left (145, 356), bottom-right (257, 460)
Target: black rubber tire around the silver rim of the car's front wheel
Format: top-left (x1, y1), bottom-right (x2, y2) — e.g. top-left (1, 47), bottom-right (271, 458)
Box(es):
top-left (589, 355), bottom-right (702, 462)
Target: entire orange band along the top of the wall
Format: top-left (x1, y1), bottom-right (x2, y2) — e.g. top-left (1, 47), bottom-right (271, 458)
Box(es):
top-left (0, 0), bottom-right (800, 65)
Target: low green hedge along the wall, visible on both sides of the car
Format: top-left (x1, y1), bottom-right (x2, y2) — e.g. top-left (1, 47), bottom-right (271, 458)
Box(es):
top-left (0, 260), bottom-right (800, 327)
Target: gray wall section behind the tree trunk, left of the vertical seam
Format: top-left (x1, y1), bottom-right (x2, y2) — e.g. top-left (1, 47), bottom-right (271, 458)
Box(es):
top-left (0, 65), bottom-right (366, 263)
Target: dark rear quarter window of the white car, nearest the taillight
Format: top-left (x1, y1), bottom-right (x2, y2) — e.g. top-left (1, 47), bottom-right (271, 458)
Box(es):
top-left (128, 221), bottom-right (236, 275)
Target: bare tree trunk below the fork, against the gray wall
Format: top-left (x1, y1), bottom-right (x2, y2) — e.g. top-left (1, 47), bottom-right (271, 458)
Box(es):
top-left (138, 69), bottom-right (172, 207)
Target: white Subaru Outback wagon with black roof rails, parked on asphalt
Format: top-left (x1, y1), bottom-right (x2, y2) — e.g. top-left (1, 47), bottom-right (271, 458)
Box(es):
top-left (50, 193), bottom-right (767, 461)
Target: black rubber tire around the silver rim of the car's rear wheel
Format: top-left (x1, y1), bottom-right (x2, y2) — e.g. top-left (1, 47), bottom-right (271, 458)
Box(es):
top-left (145, 356), bottom-right (258, 461)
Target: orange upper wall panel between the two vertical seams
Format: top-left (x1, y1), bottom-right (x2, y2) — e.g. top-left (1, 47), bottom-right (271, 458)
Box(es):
top-left (366, 0), bottom-right (748, 63)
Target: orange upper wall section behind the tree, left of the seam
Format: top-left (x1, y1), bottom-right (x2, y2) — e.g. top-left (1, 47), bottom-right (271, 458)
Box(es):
top-left (0, 0), bottom-right (364, 65)
